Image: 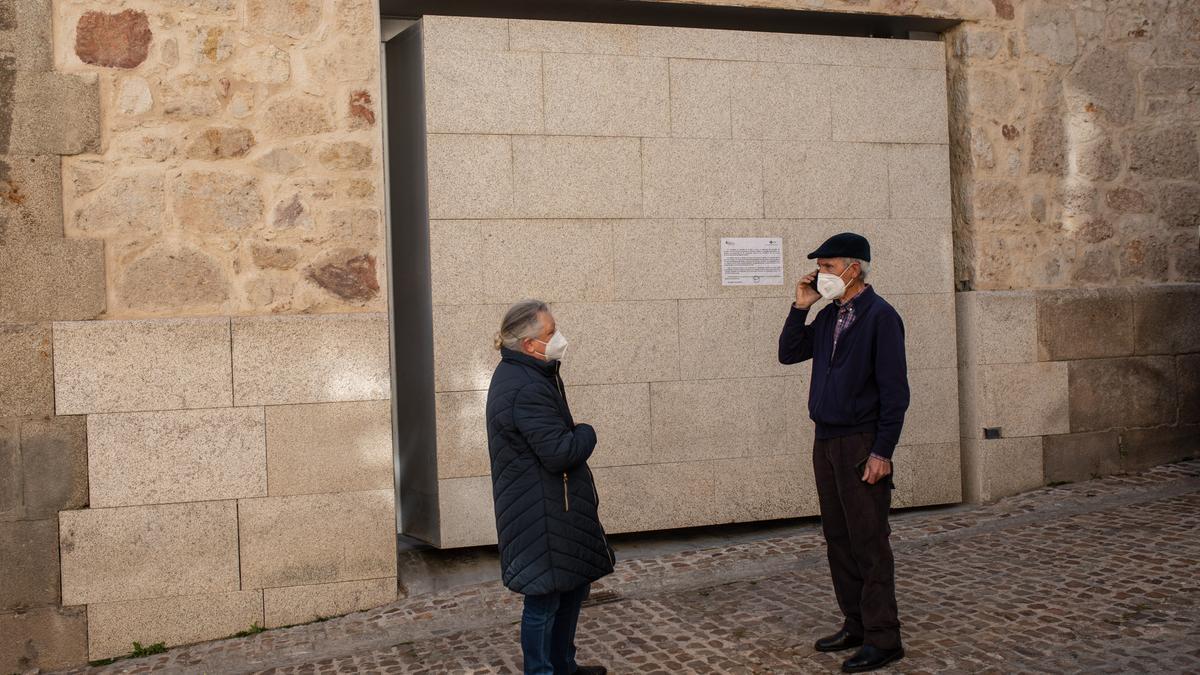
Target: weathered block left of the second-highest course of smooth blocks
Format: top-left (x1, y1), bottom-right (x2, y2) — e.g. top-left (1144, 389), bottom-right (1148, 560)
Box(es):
top-left (20, 416), bottom-right (88, 514)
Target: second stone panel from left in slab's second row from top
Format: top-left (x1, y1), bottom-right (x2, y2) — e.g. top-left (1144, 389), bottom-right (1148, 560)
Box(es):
top-left (542, 54), bottom-right (671, 136)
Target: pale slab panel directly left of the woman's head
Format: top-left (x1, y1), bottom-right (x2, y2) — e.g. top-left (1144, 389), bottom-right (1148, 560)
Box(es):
top-left (433, 303), bottom-right (506, 392)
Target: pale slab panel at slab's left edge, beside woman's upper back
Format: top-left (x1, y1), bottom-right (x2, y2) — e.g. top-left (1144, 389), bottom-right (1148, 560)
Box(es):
top-left (436, 392), bottom-right (491, 479)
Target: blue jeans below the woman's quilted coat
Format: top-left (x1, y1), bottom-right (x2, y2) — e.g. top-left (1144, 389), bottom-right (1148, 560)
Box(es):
top-left (521, 584), bottom-right (592, 675)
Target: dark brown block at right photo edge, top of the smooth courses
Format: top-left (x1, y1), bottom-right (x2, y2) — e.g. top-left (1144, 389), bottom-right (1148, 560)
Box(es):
top-left (1134, 283), bottom-right (1200, 354)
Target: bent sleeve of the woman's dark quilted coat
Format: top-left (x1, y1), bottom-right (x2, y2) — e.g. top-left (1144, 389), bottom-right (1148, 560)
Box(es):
top-left (512, 384), bottom-right (596, 473)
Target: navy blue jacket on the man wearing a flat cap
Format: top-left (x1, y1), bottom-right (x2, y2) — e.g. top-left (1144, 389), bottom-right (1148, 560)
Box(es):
top-left (779, 286), bottom-right (908, 459)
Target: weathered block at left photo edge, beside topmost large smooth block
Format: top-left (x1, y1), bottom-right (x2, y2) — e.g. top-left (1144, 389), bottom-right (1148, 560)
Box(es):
top-left (0, 324), bottom-right (54, 418)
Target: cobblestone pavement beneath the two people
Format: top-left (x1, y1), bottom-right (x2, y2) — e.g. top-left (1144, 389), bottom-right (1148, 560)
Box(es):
top-left (58, 460), bottom-right (1200, 674)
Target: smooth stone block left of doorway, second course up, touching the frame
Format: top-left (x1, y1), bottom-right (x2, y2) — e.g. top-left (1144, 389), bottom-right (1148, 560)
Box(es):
top-left (238, 489), bottom-right (396, 589)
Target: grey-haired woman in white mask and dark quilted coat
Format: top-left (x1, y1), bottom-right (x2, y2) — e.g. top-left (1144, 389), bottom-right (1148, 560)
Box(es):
top-left (487, 300), bottom-right (614, 675)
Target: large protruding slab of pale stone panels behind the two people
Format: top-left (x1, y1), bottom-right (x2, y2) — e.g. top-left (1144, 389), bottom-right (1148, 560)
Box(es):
top-left (421, 17), bottom-right (960, 546)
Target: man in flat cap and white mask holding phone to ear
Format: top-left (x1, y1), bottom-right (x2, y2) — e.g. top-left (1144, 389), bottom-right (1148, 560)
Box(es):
top-left (779, 233), bottom-right (908, 673)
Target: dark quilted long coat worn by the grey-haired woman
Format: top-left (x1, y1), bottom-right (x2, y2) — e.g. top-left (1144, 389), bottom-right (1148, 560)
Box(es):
top-left (487, 350), bottom-right (614, 596)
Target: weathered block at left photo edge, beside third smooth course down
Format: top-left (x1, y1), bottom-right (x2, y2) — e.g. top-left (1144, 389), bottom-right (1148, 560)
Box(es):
top-left (0, 518), bottom-right (59, 610)
